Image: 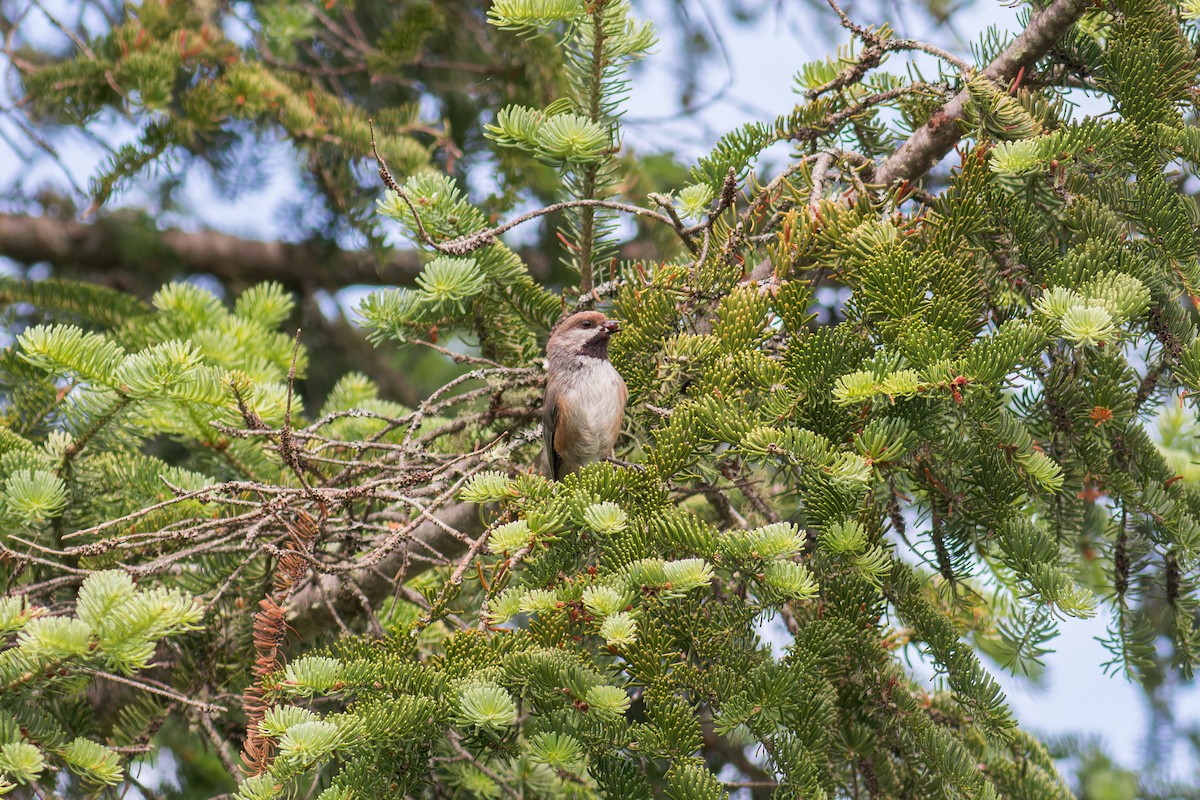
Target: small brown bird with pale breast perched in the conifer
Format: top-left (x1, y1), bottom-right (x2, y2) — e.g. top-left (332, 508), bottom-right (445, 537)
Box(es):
top-left (541, 311), bottom-right (629, 481)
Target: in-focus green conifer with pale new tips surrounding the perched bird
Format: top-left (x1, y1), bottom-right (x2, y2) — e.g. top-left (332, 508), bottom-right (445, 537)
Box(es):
top-left (0, 0), bottom-right (1200, 800)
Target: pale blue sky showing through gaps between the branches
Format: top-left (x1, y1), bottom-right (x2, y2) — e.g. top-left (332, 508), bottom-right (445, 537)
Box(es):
top-left (0, 0), bottom-right (1200, 777)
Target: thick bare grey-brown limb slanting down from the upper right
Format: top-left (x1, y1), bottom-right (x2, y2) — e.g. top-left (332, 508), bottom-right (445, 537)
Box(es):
top-left (874, 0), bottom-right (1090, 187)
